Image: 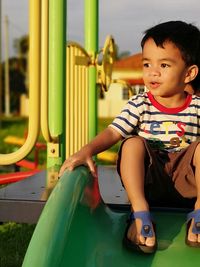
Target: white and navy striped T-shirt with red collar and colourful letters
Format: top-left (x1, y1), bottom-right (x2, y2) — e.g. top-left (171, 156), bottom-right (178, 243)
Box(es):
top-left (109, 92), bottom-right (200, 151)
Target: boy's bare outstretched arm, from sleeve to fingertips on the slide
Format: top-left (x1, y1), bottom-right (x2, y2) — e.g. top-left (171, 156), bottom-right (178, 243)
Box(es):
top-left (59, 127), bottom-right (122, 176)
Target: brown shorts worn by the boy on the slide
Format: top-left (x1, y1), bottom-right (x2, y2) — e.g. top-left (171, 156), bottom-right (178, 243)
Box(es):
top-left (117, 136), bottom-right (199, 206)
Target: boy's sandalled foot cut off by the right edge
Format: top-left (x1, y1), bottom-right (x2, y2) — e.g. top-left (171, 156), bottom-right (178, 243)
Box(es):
top-left (185, 209), bottom-right (200, 247)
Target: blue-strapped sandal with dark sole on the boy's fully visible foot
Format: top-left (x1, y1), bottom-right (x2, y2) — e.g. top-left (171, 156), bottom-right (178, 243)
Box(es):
top-left (123, 211), bottom-right (157, 253)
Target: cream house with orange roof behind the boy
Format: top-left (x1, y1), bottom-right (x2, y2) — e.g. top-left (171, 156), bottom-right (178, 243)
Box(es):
top-left (98, 53), bottom-right (144, 118)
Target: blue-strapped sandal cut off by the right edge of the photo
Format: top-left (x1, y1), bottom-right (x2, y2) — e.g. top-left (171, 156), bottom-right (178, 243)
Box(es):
top-left (185, 209), bottom-right (200, 248)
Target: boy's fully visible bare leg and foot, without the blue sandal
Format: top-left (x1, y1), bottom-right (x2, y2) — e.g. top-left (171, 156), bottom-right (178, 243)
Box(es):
top-left (120, 137), bottom-right (155, 249)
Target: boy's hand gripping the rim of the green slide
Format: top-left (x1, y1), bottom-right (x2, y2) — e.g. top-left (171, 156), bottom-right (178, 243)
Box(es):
top-left (58, 152), bottom-right (97, 177)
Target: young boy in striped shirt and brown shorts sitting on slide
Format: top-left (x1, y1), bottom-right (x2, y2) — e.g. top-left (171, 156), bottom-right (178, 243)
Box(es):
top-left (60, 21), bottom-right (200, 253)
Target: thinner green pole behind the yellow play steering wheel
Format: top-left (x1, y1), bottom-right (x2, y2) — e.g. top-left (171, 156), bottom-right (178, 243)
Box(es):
top-left (85, 0), bottom-right (99, 140)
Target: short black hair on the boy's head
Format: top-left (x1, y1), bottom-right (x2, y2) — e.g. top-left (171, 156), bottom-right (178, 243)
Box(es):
top-left (141, 21), bottom-right (200, 91)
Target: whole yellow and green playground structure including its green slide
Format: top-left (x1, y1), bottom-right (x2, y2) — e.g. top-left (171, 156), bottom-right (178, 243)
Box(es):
top-left (0, 0), bottom-right (200, 267)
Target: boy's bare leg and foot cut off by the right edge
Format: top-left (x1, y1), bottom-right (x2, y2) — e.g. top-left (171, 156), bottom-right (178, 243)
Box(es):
top-left (188, 144), bottom-right (200, 242)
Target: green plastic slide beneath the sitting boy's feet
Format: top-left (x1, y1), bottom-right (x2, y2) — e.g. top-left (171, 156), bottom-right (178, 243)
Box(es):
top-left (22, 167), bottom-right (200, 267)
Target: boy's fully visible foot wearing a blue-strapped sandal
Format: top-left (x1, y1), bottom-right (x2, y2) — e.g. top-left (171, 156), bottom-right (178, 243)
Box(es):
top-left (123, 211), bottom-right (157, 253)
